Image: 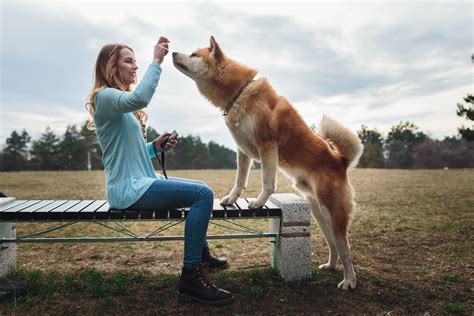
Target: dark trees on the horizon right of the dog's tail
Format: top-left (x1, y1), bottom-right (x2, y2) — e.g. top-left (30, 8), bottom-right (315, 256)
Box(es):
top-left (357, 94), bottom-right (474, 169)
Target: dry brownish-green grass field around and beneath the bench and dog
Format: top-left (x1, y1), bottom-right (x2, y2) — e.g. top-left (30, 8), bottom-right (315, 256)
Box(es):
top-left (0, 169), bottom-right (474, 315)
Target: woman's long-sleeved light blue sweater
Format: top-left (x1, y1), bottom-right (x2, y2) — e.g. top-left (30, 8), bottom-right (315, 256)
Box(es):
top-left (94, 64), bottom-right (161, 209)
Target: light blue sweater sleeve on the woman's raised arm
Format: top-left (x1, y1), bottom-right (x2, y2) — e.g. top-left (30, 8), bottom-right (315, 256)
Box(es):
top-left (95, 64), bottom-right (161, 119)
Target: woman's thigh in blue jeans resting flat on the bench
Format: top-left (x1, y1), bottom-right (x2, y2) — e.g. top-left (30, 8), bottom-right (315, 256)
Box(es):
top-left (130, 178), bottom-right (209, 210)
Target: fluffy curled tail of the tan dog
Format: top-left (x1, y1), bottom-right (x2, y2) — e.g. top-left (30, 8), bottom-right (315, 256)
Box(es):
top-left (319, 116), bottom-right (364, 169)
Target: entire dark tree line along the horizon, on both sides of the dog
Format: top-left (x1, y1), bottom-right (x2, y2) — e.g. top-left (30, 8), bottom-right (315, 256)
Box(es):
top-left (0, 94), bottom-right (474, 171)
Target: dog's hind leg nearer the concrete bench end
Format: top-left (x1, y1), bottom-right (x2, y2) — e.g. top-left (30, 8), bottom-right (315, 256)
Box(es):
top-left (308, 197), bottom-right (338, 270)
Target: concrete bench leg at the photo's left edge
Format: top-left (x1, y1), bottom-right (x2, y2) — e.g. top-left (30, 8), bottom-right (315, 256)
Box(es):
top-left (0, 198), bottom-right (16, 277)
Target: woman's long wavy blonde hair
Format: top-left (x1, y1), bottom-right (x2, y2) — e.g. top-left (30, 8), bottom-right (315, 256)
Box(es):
top-left (86, 44), bottom-right (148, 138)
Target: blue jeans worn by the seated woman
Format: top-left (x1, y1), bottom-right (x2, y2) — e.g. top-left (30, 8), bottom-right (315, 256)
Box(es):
top-left (130, 177), bottom-right (214, 268)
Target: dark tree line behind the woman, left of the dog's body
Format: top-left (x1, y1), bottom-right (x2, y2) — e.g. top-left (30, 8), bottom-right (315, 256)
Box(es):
top-left (0, 122), bottom-right (237, 171)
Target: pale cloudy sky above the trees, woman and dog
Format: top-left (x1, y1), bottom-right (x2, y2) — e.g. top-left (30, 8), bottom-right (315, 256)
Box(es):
top-left (0, 0), bottom-right (474, 149)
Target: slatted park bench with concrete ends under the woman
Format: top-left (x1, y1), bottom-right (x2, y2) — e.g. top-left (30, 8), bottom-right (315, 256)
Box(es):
top-left (0, 193), bottom-right (311, 281)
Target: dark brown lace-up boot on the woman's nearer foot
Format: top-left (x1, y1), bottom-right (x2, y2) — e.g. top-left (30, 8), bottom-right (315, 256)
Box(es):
top-left (177, 265), bottom-right (233, 305)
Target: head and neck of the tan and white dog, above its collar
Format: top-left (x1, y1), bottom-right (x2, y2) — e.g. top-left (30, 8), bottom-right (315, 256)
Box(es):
top-left (173, 36), bottom-right (257, 107)
